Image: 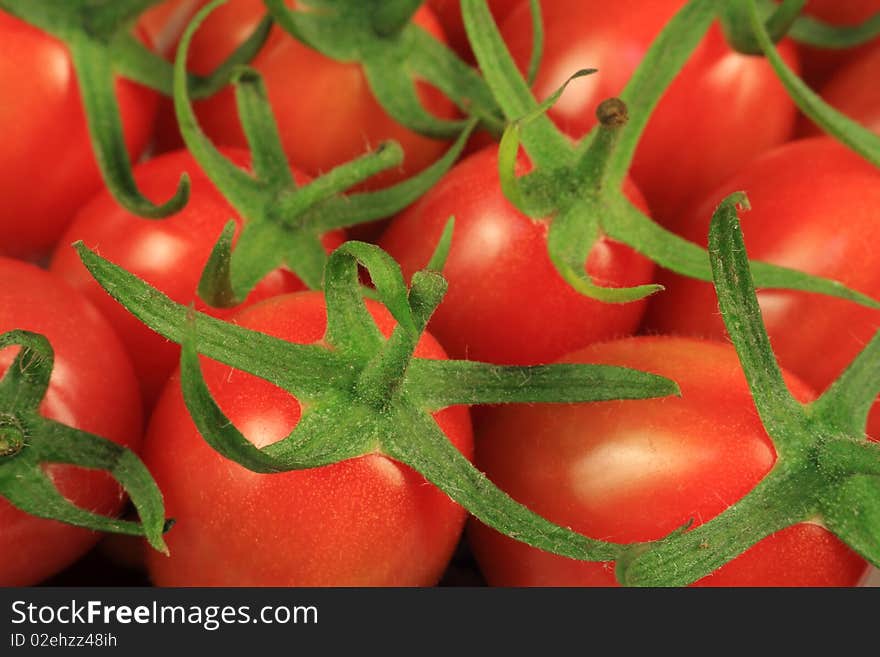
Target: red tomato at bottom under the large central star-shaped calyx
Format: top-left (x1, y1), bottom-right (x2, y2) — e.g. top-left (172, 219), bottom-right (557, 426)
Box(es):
top-left (144, 292), bottom-right (473, 586)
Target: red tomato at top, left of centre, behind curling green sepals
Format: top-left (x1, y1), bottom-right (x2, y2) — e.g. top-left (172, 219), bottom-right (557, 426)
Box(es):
top-left (161, 0), bottom-right (456, 188)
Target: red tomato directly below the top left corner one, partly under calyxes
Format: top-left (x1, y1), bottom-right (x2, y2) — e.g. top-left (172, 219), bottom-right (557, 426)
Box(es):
top-left (50, 151), bottom-right (342, 408)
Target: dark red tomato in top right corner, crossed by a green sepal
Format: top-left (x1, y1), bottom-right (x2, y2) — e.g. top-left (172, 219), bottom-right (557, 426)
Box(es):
top-left (800, 0), bottom-right (880, 84)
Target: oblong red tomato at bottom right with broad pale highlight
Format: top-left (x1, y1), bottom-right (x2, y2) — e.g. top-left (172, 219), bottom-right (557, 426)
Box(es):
top-left (469, 337), bottom-right (866, 586)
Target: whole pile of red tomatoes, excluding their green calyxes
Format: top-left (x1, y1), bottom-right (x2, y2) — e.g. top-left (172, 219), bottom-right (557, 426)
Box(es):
top-left (0, 0), bottom-right (880, 586)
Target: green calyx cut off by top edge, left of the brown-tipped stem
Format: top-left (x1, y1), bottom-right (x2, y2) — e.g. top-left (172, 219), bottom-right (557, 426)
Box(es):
top-left (266, 0), bottom-right (503, 139)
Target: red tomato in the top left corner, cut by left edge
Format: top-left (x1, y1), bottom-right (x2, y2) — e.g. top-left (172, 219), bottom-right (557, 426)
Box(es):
top-left (0, 12), bottom-right (158, 258)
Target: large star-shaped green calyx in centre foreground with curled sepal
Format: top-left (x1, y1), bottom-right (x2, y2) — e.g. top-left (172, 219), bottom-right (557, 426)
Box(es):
top-left (76, 236), bottom-right (678, 561)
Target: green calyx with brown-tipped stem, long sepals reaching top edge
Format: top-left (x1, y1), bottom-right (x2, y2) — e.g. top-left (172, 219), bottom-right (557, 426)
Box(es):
top-left (462, 0), bottom-right (880, 308)
